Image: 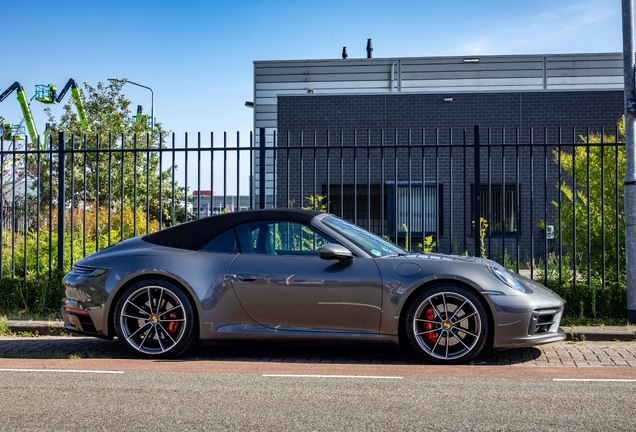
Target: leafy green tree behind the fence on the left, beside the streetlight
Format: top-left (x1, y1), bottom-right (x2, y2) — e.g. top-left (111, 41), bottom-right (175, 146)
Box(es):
top-left (41, 82), bottom-right (185, 230)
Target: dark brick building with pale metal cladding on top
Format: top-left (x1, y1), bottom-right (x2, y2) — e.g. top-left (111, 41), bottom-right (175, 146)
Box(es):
top-left (255, 54), bottom-right (623, 259)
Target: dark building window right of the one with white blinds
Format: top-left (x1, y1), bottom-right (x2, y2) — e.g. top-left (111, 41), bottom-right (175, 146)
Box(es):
top-left (471, 184), bottom-right (519, 235)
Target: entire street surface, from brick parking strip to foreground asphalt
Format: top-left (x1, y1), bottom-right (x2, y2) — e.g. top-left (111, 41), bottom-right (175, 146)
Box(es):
top-left (0, 337), bottom-right (636, 431)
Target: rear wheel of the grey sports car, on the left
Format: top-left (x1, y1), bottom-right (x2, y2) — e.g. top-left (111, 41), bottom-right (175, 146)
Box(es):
top-left (113, 279), bottom-right (196, 358)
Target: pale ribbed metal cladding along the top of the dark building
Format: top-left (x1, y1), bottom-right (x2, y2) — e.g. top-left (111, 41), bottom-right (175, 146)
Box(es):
top-left (254, 53), bottom-right (623, 129)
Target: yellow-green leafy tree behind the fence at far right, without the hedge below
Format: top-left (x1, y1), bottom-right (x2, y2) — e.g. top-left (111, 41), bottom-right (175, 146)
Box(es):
top-left (552, 119), bottom-right (626, 285)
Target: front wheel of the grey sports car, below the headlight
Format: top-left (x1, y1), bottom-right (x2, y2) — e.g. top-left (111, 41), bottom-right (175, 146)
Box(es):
top-left (405, 285), bottom-right (489, 364)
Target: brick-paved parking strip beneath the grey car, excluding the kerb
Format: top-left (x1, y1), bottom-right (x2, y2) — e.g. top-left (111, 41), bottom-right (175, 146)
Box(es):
top-left (0, 336), bottom-right (636, 367)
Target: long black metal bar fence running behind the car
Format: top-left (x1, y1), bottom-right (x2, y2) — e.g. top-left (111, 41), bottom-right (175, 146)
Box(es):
top-left (0, 126), bottom-right (624, 292)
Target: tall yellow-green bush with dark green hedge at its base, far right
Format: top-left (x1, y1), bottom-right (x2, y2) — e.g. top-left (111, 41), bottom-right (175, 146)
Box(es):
top-left (536, 119), bottom-right (627, 320)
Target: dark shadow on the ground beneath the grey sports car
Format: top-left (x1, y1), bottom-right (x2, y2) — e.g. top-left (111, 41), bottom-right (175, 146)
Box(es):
top-left (0, 337), bottom-right (542, 366)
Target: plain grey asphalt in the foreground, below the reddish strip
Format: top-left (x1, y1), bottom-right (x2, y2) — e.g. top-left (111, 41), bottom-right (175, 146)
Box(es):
top-left (0, 371), bottom-right (636, 431)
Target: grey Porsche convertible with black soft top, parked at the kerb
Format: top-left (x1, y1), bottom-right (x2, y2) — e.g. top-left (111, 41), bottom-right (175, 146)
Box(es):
top-left (61, 209), bottom-right (565, 364)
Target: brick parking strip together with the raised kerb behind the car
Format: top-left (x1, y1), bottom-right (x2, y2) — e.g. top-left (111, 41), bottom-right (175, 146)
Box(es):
top-left (0, 320), bottom-right (636, 369)
